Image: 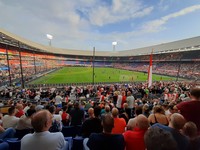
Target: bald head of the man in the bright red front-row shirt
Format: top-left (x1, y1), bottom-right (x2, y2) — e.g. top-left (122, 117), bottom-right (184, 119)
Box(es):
top-left (136, 115), bottom-right (150, 130)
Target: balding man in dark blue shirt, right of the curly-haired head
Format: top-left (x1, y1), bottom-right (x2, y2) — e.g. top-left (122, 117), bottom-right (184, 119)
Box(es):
top-left (152, 113), bottom-right (189, 150)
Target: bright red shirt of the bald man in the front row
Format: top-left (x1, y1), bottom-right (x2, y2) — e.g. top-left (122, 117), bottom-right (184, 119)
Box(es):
top-left (123, 128), bottom-right (146, 150)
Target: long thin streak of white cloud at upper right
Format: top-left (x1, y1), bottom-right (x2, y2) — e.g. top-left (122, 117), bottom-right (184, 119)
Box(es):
top-left (142, 5), bottom-right (200, 33)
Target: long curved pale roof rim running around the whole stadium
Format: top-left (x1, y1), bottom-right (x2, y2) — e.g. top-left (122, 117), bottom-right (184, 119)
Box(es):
top-left (0, 29), bottom-right (200, 57)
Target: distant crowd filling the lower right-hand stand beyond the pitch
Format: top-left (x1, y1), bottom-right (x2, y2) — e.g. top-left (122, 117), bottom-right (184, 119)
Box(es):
top-left (114, 62), bottom-right (200, 80)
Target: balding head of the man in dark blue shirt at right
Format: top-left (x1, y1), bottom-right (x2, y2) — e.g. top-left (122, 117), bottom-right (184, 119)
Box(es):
top-left (169, 113), bottom-right (186, 130)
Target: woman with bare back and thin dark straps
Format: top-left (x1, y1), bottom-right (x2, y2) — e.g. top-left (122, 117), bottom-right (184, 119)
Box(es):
top-left (148, 105), bottom-right (168, 126)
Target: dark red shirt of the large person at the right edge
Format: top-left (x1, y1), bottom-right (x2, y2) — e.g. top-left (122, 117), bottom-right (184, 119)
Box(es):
top-left (177, 100), bottom-right (200, 133)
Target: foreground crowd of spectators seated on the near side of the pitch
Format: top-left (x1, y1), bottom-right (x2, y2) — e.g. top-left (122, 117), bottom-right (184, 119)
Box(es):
top-left (0, 81), bottom-right (200, 150)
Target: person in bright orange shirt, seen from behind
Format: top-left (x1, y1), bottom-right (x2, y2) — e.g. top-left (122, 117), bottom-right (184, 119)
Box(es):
top-left (112, 108), bottom-right (126, 134)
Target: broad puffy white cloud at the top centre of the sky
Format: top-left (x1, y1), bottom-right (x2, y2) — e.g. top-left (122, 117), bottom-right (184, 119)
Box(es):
top-left (88, 0), bottom-right (153, 26)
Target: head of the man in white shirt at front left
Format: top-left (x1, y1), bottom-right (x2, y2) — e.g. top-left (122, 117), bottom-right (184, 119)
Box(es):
top-left (31, 110), bottom-right (52, 132)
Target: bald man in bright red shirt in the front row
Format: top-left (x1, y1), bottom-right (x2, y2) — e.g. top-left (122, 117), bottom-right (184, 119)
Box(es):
top-left (123, 115), bottom-right (150, 150)
